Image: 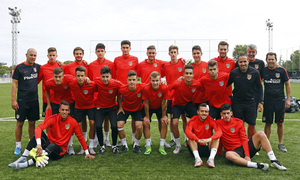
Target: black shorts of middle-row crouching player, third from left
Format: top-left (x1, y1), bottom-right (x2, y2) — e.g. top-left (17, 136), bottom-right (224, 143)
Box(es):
top-left (95, 106), bottom-right (118, 128)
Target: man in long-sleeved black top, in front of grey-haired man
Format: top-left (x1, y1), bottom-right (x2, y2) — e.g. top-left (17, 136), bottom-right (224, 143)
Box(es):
top-left (227, 54), bottom-right (263, 138)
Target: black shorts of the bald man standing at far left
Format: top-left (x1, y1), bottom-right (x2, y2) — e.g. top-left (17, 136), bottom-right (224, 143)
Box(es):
top-left (15, 100), bottom-right (40, 121)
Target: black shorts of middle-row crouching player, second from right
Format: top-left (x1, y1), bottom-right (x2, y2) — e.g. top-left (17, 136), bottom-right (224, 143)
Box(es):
top-left (172, 101), bottom-right (197, 119)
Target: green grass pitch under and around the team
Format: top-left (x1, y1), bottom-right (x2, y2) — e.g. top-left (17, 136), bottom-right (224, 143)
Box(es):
top-left (0, 83), bottom-right (300, 179)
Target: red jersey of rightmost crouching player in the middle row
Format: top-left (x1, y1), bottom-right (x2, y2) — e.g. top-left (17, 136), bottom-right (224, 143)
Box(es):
top-left (200, 72), bottom-right (231, 108)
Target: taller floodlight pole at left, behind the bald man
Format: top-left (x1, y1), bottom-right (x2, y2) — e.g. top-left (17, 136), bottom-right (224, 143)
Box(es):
top-left (8, 7), bottom-right (21, 71)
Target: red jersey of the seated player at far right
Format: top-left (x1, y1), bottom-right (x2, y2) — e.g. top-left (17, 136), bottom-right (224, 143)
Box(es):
top-left (216, 118), bottom-right (250, 157)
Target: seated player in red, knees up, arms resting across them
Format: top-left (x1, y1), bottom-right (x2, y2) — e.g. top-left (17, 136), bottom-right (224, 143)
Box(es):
top-left (185, 103), bottom-right (222, 168)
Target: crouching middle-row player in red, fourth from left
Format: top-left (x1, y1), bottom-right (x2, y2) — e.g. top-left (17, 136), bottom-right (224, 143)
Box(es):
top-left (118, 70), bottom-right (145, 154)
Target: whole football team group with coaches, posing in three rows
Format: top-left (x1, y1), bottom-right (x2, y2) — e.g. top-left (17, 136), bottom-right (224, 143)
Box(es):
top-left (8, 40), bottom-right (291, 170)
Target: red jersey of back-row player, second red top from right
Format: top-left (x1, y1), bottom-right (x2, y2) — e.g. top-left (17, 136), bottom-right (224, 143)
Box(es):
top-left (192, 61), bottom-right (208, 103)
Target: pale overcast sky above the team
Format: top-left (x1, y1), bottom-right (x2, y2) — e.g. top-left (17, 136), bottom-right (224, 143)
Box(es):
top-left (0, 0), bottom-right (300, 66)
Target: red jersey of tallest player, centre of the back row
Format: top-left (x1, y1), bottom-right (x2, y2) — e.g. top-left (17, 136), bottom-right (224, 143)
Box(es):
top-left (114, 55), bottom-right (139, 84)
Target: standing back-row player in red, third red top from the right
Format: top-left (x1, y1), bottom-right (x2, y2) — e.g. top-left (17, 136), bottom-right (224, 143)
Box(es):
top-left (161, 45), bottom-right (187, 148)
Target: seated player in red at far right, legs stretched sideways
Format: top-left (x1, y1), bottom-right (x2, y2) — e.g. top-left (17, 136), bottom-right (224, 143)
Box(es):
top-left (217, 104), bottom-right (286, 170)
